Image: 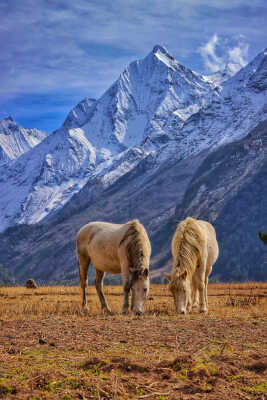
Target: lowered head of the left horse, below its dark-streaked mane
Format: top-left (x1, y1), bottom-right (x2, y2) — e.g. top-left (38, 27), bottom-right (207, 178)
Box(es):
top-left (131, 268), bottom-right (149, 315)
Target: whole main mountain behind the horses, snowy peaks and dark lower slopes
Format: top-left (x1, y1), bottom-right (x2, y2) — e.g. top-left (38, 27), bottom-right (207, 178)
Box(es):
top-left (0, 46), bottom-right (267, 280)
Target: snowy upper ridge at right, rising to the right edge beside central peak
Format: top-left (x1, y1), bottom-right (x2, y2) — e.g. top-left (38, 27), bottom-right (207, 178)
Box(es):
top-left (168, 50), bottom-right (267, 158)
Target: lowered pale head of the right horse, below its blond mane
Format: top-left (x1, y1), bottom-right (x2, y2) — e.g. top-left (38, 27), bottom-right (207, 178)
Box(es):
top-left (165, 271), bottom-right (191, 314)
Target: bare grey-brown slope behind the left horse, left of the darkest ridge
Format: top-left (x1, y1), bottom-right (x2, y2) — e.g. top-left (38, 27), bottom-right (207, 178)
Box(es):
top-left (0, 148), bottom-right (205, 282)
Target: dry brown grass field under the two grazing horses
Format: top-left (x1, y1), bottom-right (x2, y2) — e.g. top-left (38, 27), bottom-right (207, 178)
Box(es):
top-left (0, 283), bottom-right (267, 400)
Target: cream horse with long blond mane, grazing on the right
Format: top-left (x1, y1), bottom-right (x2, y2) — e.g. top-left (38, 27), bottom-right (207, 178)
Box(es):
top-left (165, 217), bottom-right (219, 314)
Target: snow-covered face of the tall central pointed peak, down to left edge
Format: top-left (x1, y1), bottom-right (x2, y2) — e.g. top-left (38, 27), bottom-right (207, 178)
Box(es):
top-left (0, 46), bottom-right (218, 230)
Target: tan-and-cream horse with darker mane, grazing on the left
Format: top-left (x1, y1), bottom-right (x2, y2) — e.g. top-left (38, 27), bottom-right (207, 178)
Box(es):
top-left (76, 219), bottom-right (151, 315)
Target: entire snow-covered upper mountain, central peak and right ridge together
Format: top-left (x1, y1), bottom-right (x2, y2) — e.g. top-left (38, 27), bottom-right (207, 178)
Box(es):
top-left (0, 46), bottom-right (267, 230)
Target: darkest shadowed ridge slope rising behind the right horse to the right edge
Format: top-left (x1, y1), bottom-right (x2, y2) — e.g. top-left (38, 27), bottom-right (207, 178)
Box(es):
top-left (152, 120), bottom-right (267, 281)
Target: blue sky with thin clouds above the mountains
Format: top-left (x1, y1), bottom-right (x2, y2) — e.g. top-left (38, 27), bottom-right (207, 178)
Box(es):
top-left (0, 0), bottom-right (267, 132)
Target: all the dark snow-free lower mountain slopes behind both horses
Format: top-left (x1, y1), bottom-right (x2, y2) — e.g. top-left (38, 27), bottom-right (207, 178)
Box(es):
top-left (0, 121), bottom-right (267, 281)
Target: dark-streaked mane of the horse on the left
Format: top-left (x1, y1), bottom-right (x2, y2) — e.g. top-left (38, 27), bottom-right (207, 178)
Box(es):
top-left (120, 219), bottom-right (150, 275)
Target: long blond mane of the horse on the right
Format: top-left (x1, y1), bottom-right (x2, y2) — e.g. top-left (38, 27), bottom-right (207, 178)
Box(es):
top-left (172, 217), bottom-right (204, 277)
